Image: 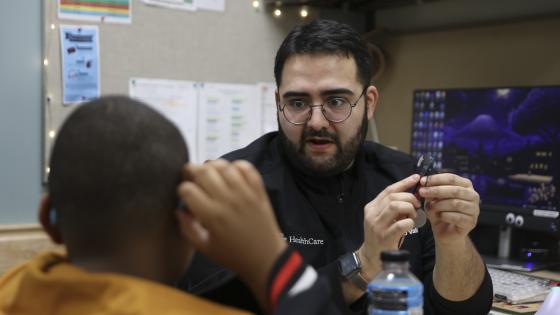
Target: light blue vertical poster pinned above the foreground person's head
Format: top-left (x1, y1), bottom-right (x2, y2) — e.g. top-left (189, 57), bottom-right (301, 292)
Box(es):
top-left (60, 25), bottom-right (100, 104)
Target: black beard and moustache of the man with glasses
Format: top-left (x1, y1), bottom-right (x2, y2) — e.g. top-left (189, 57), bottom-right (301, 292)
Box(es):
top-left (278, 112), bottom-right (368, 177)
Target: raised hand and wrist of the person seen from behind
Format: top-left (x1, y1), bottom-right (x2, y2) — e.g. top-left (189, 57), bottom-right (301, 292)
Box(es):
top-left (177, 160), bottom-right (287, 307)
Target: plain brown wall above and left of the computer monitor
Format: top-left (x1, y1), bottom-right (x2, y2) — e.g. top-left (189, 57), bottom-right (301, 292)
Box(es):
top-left (375, 18), bottom-right (560, 152)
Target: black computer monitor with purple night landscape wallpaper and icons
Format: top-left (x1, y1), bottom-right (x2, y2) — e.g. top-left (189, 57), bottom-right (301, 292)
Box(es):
top-left (411, 86), bottom-right (560, 235)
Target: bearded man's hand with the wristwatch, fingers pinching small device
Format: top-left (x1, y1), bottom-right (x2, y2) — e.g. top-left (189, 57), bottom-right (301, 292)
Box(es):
top-left (343, 174), bottom-right (420, 303)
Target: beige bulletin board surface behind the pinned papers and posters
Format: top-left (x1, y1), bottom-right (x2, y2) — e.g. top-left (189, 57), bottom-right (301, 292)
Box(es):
top-left (43, 0), bottom-right (306, 179)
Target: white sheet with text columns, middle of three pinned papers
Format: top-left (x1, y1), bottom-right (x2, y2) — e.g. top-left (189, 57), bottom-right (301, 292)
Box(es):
top-left (198, 83), bottom-right (262, 162)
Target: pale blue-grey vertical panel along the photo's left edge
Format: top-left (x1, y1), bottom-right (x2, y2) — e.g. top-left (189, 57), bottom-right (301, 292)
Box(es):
top-left (0, 0), bottom-right (42, 225)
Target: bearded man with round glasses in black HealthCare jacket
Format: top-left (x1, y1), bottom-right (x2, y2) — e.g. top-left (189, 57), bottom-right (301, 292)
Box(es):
top-left (179, 20), bottom-right (492, 315)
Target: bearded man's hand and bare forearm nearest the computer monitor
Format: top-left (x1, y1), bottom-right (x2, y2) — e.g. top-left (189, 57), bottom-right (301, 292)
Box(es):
top-left (419, 174), bottom-right (485, 301)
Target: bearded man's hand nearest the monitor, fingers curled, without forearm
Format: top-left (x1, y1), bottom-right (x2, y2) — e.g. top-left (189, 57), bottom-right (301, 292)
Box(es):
top-left (419, 173), bottom-right (480, 246)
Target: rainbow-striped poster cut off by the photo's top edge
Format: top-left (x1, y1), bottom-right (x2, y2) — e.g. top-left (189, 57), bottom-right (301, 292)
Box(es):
top-left (58, 0), bottom-right (132, 23)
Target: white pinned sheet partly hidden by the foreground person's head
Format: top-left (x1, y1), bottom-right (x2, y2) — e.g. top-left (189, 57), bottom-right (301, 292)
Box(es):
top-left (128, 78), bottom-right (198, 162)
